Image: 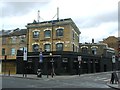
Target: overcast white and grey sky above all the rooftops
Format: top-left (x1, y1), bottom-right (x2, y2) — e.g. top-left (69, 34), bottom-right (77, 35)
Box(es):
top-left (0, 0), bottom-right (120, 43)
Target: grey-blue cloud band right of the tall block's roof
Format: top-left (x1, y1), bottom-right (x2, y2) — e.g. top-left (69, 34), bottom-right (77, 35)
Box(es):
top-left (75, 10), bottom-right (118, 28)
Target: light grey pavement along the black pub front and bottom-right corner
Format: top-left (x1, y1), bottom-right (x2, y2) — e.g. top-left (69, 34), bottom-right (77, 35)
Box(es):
top-left (0, 72), bottom-right (120, 90)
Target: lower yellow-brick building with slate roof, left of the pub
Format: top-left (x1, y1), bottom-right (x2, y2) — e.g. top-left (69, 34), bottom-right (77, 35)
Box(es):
top-left (0, 28), bottom-right (27, 73)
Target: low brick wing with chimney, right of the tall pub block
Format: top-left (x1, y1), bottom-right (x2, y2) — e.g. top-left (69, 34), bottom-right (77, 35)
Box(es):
top-left (79, 39), bottom-right (116, 72)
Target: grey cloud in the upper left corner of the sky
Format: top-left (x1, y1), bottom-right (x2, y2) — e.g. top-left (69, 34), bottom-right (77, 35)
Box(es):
top-left (1, 2), bottom-right (48, 18)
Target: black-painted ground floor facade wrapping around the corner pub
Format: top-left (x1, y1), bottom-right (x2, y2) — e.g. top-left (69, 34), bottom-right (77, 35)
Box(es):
top-left (16, 51), bottom-right (117, 75)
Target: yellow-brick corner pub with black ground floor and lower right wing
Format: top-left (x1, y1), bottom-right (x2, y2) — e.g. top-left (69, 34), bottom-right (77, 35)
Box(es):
top-left (16, 18), bottom-right (115, 75)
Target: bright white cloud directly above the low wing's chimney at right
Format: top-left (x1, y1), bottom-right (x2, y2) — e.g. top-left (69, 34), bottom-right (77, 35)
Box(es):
top-left (80, 22), bottom-right (118, 42)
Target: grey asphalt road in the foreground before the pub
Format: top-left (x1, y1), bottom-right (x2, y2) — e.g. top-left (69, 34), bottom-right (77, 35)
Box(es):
top-left (2, 73), bottom-right (114, 89)
